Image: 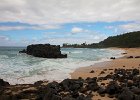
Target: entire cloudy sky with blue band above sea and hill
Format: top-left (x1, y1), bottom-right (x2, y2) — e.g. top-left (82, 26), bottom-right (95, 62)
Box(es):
top-left (0, 0), bottom-right (140, 46)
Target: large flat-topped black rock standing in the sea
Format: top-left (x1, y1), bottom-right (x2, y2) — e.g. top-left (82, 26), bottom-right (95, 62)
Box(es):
top-left (19, 44), bottom-right (67, 58)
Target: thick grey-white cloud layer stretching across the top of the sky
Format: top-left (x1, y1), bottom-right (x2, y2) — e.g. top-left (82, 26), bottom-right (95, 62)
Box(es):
top-left (0, 0), bottom-right (140, 24)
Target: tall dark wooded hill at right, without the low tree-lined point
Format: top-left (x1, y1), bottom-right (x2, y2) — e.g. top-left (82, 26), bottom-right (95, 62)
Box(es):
top-left (99, 31), bottom-right (140, 48)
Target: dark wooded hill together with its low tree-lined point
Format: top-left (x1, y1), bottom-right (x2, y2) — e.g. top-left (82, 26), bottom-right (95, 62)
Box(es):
top-left (63, 31), bottom-right (140, 48)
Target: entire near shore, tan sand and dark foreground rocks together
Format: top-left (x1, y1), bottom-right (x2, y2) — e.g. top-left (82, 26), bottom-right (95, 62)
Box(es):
top-left (0, 48), bottom-right (140, 100)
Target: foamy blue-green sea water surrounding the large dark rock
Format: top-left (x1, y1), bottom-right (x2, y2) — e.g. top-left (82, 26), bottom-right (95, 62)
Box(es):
top-left (0, 47), bottom-right (124, 84)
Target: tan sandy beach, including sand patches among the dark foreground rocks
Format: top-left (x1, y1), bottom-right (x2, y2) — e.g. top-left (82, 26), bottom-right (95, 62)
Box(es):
top-left (71, 48), bottom-right (140, 100)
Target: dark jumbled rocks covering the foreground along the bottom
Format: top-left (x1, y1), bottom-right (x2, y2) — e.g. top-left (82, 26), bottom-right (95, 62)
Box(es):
top-left (0, 69), bottom-right (140, 100)
